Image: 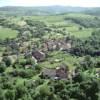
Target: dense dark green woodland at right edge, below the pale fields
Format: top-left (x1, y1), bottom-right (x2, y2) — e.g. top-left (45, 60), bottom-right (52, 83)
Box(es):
top-left (71, 30), bottom-right (100, 56)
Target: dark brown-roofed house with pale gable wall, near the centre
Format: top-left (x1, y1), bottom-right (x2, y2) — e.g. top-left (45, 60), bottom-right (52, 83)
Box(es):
top-left (32, 50), bottom-right (46, 62)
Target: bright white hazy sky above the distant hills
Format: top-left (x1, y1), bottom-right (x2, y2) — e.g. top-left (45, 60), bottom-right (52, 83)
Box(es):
top-left (0, 0), bottom-right (100, 7)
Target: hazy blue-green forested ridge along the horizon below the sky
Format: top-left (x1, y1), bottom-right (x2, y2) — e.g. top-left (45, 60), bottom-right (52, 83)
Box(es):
top-left (0, 6), bottom-right (100, 16)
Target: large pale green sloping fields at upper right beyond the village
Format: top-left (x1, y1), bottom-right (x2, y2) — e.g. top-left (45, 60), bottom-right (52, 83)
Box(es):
top-left (31, 13), bottom-right (98, 38)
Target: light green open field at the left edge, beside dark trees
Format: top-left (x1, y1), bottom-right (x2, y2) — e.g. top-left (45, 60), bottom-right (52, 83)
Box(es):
top-left (0, 28), bottom-right (17, 40)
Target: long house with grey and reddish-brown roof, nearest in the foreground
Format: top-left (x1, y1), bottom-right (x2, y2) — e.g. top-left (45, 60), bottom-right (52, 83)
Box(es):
top-left (41, 65), bottom-right (69, 79)
